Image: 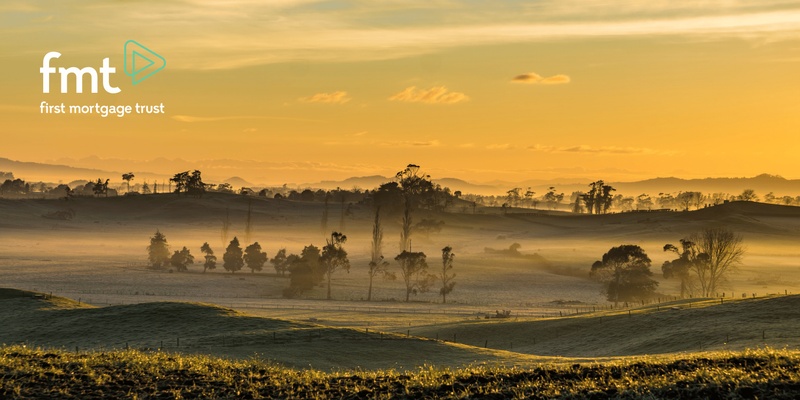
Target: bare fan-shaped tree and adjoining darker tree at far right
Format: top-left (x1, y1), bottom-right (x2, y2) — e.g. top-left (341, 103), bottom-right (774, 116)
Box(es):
top-left (664, 228), bottom-right (745, 297)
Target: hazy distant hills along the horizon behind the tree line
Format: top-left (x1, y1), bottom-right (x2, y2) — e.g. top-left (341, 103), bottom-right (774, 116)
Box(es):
top-left (0, 158), bottom-right (800, 196)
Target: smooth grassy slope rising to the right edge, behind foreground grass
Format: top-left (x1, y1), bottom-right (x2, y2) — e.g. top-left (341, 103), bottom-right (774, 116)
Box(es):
top-left (413, 295), bottom-right (800, 357)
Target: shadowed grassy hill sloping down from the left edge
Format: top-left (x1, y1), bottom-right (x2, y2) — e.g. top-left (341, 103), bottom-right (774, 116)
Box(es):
top-left (0, 289), bottom-right (534, 369)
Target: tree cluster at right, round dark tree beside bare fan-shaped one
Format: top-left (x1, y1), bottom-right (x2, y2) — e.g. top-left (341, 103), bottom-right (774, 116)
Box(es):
top-left (590, 228), bottom-right (745, 304)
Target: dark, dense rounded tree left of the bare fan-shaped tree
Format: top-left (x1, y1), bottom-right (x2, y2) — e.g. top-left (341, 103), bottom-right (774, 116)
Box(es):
top-left (589, 244), bottom-right (658, 306)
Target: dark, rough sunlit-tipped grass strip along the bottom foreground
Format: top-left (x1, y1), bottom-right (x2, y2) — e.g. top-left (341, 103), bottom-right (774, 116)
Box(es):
top-left (0, 346), bottom-right (800, 399)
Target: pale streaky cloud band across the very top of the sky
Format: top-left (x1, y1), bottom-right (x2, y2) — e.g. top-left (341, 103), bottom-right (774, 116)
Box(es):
top-left (0, 0), bottom-right (800, 70)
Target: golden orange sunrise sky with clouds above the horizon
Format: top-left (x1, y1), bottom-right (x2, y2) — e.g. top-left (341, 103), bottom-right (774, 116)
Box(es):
top-left (0, 0), bottom-right (800, 184)
